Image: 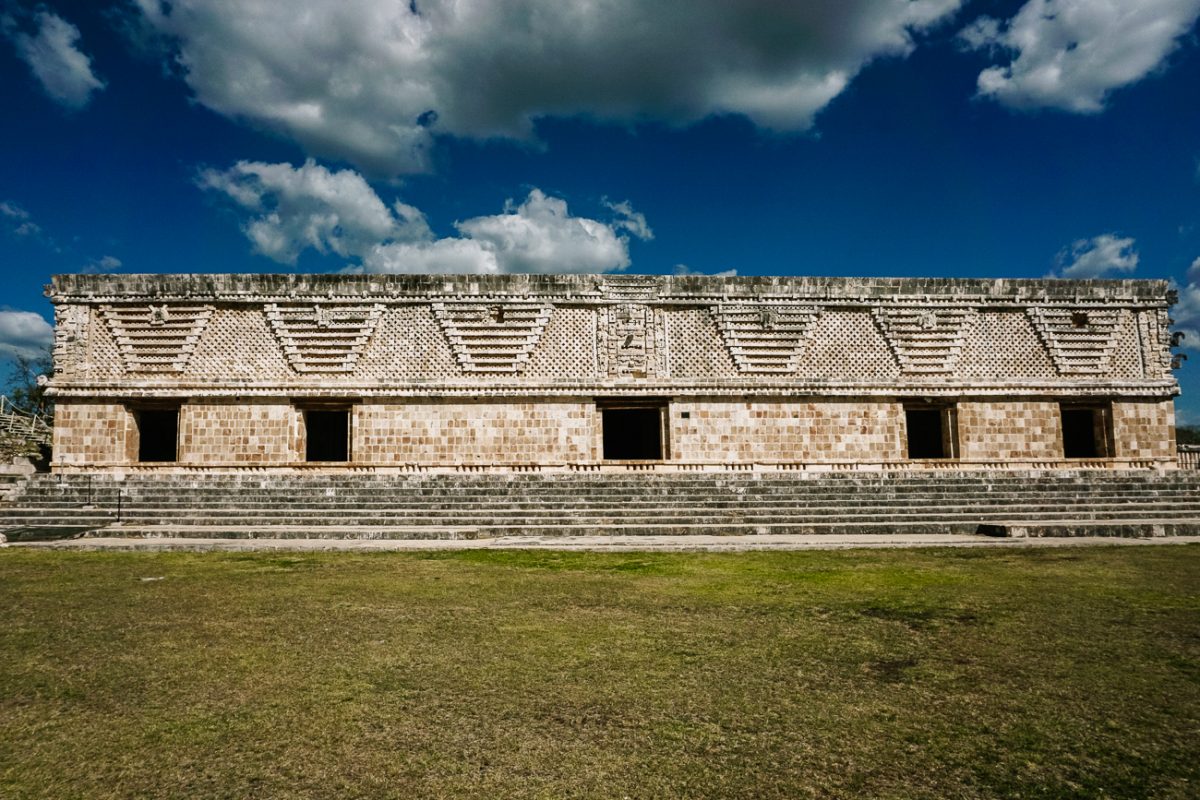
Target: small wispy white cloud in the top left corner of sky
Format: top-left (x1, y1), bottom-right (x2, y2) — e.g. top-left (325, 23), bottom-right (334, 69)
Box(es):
top-left (13, 11), bottom-right (104, 109)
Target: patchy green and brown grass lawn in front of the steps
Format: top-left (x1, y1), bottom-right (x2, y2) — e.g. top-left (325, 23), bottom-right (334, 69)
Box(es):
top-left (0, 546), bottom-right (1200, 800)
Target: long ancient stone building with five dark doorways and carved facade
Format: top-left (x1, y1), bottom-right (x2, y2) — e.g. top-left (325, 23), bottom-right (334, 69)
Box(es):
top-left (47, 275), bottom-right (1178, 471)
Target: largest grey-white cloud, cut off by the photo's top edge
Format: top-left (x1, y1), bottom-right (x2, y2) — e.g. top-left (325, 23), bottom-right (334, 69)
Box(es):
top-left (134, 0), bottom-right (961, 174)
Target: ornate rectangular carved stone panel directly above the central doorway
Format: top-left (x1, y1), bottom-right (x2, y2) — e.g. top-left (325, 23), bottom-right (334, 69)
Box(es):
top-left (596, 303), bottom-right (667, 378)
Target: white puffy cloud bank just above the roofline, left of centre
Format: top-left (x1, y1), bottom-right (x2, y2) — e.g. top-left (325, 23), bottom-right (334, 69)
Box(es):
top-left (205, 161), bottom-right (653, 272)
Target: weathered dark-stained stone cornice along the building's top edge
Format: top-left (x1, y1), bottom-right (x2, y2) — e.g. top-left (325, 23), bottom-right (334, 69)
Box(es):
top-left (46, 273), bottom-right (1171, 307)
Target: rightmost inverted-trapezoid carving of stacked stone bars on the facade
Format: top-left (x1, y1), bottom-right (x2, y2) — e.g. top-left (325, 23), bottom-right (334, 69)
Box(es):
top-left (1026, 306), bottom-right (1123, 375)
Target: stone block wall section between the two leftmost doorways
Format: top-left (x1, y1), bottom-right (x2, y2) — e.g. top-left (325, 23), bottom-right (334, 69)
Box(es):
top-left (179, 401), bottom-right (304, 465)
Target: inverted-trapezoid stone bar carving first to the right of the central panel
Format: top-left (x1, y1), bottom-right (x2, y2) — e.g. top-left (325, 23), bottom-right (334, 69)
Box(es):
top-left (713, 303), bottom-right (821, 374)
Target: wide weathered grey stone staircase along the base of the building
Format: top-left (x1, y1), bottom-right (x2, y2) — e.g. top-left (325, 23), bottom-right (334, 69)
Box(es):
top-left (0, 470), bottom-right (1200, 541)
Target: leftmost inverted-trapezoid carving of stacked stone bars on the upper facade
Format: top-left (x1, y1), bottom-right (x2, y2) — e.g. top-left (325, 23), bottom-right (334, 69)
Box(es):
top-left (100, 303), bottom-right (212, 372)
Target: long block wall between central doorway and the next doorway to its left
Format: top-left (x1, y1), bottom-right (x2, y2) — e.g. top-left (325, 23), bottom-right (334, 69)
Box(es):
top-left (350, 399), bottom-right (599, 465)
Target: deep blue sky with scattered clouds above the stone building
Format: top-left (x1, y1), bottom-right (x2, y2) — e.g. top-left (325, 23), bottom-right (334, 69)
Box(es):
top-left (7, 0), bottom-right (1200, 422)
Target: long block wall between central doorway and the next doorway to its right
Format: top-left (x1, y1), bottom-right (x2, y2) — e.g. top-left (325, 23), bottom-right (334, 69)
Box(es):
top-left (670, 399), bottom-right (904, 463)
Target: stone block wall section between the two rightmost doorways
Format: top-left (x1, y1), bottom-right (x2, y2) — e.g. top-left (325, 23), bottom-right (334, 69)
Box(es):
top-left (958, 401), bottom-right (1062, 461)
